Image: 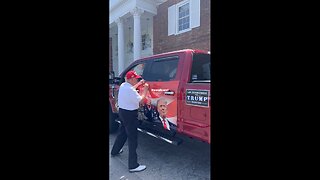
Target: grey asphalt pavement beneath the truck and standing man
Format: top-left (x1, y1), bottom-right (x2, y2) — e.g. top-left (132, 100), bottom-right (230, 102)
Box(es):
top-left (109, 129), bottom-right (211, 180)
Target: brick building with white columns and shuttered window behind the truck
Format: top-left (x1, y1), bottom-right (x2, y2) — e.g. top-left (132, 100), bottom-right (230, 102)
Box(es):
top-left (109, 0), bottom-right (210, 75)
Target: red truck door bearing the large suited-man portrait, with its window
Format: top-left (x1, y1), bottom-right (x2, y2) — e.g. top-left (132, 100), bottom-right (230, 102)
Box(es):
top-left (143, 55), bottom-right (183, 132)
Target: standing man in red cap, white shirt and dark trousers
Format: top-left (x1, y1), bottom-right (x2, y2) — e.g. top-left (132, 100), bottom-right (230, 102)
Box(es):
top-left (111, 71), bottom-right (149, 172)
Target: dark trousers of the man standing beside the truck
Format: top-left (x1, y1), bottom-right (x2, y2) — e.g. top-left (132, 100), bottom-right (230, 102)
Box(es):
top-left (111, 108), bottom-right (139, 169)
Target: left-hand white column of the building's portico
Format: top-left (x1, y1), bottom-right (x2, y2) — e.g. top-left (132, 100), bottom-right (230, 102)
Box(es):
top-left (116, 18), bottom-right (124, 74)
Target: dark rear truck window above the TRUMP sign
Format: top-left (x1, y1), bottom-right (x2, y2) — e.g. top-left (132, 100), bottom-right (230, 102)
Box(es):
top-left (190, 54), bottom-right (211, 83)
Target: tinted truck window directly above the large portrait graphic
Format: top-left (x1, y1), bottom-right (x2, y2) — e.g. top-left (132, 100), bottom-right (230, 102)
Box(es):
top-left (144, 57), bottom-right (179, 81)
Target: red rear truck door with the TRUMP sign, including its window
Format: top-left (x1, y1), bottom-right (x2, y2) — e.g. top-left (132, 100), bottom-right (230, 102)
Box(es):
top-left (178, 53), bottom-right (211, 143)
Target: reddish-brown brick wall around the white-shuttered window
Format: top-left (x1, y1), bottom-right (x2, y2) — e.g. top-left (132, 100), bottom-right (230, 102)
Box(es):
top-left (153, 0), bottom-right (210, 54)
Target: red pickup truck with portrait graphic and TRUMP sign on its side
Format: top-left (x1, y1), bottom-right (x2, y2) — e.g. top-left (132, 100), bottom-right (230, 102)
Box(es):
top-left (109, 49), bottom-right (211, 145)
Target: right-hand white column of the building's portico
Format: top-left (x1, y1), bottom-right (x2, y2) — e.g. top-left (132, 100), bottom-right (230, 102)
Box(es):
top-left (131, 8), bottom-right (144, 61)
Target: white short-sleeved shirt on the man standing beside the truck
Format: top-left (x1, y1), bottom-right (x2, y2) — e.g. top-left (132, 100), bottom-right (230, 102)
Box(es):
top-left (118, 82), bottom-right (142, 110)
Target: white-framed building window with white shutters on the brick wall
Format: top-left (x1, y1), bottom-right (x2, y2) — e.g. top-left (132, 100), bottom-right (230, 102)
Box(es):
top-left (168, 0), bottom-right (200, 36)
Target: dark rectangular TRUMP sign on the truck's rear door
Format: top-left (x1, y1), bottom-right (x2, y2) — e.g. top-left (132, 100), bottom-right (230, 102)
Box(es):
top-left (186, 89), bottom-right (209, 107)
